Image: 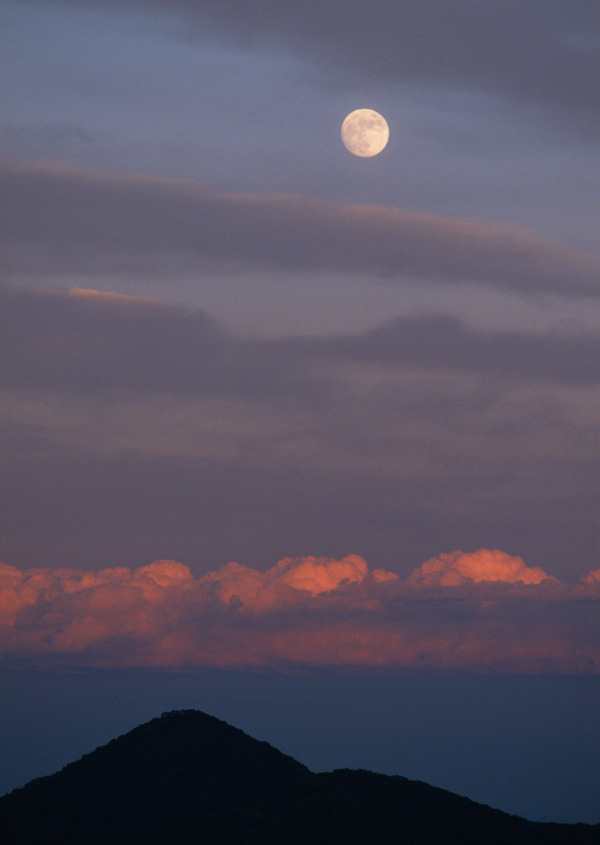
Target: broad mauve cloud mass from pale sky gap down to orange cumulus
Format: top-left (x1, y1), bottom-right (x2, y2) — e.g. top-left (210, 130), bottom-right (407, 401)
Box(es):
top-left (0, 286), bottom-right (599, 579)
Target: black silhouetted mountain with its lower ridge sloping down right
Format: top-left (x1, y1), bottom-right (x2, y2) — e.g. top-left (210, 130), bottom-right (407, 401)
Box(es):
top-left (0, 710), bottom-right (600, 845)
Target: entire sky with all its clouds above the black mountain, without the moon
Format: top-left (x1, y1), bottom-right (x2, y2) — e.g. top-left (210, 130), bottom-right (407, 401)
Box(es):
top-left (0, 0), bottom-right (600, 821)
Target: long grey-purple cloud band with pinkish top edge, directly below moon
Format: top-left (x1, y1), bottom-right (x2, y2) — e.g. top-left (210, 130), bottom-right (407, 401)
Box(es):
top-left (0, 161), bottom-right (600, 295)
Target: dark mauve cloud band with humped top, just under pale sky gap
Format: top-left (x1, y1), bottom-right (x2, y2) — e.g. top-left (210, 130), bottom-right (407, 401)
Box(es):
top-left (0, 286), bottom-right (600, 392)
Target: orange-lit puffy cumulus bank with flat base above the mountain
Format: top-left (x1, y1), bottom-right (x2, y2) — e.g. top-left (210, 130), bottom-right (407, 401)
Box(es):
top-left (0, 549), bottom-right (600, 673)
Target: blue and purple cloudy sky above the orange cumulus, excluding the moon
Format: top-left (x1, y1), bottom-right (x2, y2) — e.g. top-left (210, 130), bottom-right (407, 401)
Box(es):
top-left (0, 0), bottom-right (600, 815)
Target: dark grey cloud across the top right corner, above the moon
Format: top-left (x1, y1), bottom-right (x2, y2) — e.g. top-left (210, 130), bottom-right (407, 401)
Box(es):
top-left (37, 0), bottom-right (600, 135)
